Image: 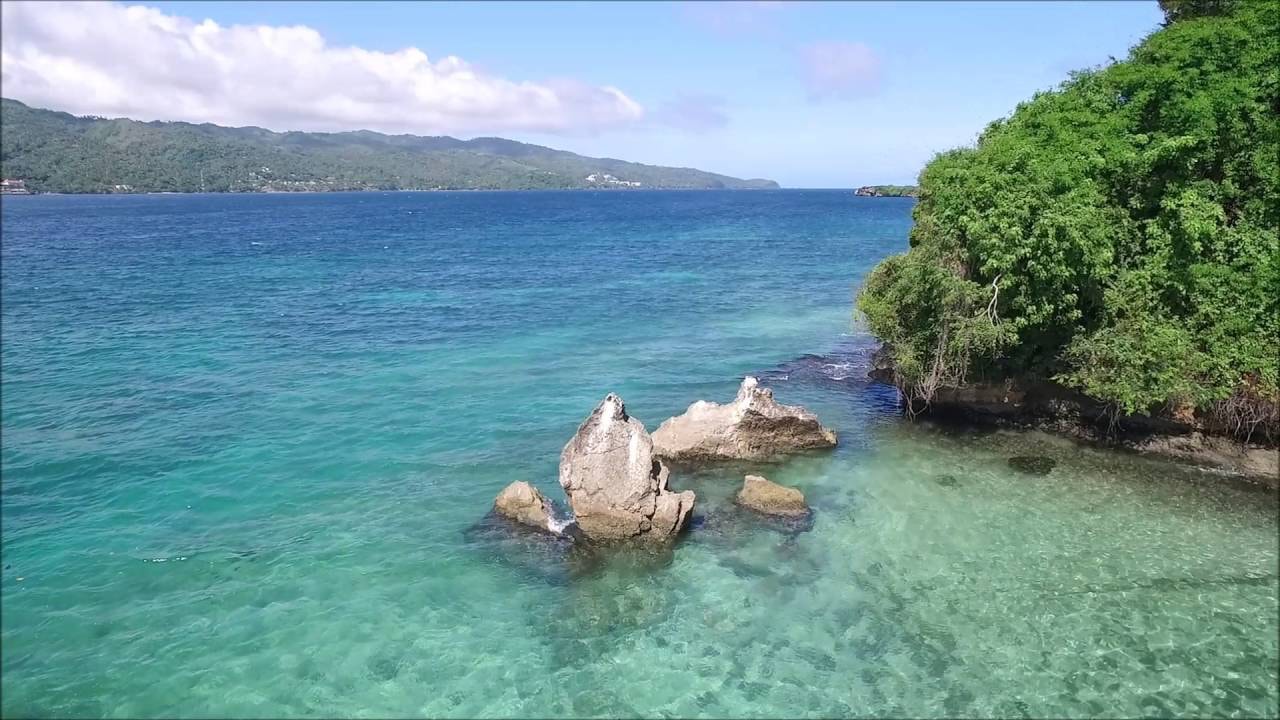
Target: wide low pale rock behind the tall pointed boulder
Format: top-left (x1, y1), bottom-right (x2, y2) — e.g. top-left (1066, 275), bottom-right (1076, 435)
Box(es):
top-left (653, 377), bottom-right (836, 462)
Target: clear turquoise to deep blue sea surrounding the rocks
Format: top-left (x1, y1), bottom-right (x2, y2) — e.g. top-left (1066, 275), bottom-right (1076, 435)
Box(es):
top-left (0, 191), bottom-right (1280, 717)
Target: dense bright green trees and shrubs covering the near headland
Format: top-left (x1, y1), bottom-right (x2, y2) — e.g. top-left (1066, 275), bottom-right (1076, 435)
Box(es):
top-left (858, 0), bottom-right (1280, 441)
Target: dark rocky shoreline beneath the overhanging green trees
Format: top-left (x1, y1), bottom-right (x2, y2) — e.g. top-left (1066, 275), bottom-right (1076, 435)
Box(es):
top-left (869, 363), bottom-right (1280, 487)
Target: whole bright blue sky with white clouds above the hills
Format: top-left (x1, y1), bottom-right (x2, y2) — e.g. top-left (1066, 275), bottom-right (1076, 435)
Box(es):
top-left (0, 0), bottom-right (1162, 187)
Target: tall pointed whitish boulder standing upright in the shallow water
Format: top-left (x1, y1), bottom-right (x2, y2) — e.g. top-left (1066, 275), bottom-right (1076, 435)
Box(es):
top-left (559, 392), bottom-right (694, 539)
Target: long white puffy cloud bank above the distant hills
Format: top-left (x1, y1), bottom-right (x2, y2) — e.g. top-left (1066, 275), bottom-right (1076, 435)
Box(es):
top-left (0, 0), bottom-right (644, 135)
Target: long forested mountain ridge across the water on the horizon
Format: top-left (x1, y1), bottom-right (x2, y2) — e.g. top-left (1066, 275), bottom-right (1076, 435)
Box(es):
top-left (0, 99), bottom-right (778, 192)
